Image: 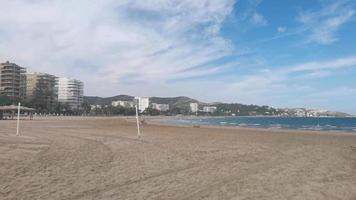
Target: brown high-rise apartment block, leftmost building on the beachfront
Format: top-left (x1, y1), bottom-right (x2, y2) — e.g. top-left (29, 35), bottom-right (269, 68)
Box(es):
top-left (0, 61), bottom-right (26, 101)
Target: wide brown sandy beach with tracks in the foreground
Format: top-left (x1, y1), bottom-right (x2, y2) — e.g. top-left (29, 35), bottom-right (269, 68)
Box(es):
top-left (0, 118), bottom-right (356, 200)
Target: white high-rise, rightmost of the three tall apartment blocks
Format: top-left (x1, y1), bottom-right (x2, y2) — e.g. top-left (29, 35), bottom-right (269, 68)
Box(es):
top-left (58, 78), bottom-right (84, 109)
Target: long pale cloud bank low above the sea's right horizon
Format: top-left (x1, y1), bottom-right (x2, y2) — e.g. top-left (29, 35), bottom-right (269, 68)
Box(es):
top-left (228, 56), bottom-right (356, 108)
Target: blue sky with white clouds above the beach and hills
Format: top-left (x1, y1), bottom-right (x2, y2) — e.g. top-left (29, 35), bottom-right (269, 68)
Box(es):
top-left (0, 0), bottom-right (356, 114)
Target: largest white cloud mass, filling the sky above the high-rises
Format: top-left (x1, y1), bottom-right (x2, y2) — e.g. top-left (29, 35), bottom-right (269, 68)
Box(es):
top-left (0, 0), bottom-right (234, 95)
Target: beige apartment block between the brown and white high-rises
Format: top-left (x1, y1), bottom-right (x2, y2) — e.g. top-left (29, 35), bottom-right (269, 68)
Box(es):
top-left (26, 73), bottom-right (58, 110)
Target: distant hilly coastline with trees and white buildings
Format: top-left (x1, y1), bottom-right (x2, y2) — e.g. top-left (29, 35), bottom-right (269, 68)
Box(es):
top-left (84, 94), bottom-right (352, 117)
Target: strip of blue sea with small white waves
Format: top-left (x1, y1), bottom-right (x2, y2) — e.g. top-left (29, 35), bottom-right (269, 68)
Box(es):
top-left (165, 116), bottom-right (356, 133)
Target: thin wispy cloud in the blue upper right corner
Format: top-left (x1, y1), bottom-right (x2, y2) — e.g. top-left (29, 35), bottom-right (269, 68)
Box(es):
top-left (298, 0), bottom-right (356, 45)
